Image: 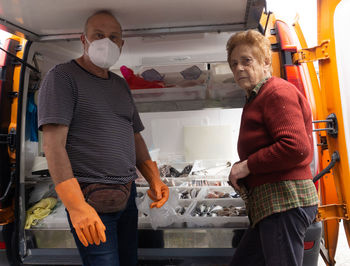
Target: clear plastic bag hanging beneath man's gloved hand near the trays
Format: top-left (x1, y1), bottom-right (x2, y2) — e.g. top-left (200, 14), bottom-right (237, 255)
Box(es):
top-left (136, 190), bottom-right (182, 230)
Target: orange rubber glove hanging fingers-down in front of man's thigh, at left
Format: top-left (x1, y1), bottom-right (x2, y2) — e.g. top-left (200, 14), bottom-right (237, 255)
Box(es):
top-left (55, 178), bottom-right (106, 247)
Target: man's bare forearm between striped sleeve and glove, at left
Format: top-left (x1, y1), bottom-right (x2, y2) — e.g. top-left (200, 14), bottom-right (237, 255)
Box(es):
top-left (43, 124), bottom-right (74, 185)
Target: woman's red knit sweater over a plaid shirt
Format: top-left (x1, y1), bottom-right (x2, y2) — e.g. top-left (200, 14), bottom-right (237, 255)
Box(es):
top-left (237, 77), bottom-right (313, 188)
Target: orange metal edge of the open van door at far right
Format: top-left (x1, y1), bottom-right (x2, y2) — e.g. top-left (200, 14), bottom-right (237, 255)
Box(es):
top-left (317, 0), bottom-right (350, 265)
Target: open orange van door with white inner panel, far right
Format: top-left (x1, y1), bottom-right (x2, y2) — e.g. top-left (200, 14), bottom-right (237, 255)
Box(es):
top-left (293, 0), bottom-right (350, 265)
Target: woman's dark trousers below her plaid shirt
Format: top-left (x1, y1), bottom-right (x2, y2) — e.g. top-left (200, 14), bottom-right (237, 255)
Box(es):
top-left (230, 206), bottom-right (317, 266)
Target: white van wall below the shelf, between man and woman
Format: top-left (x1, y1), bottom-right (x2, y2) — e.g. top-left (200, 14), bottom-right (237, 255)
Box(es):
top-left (140, 108), bottom-right (242, 162)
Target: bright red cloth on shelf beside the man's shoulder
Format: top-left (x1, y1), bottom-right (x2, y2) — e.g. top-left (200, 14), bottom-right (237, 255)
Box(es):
top-left (120, 66), bottom-right (165, 90)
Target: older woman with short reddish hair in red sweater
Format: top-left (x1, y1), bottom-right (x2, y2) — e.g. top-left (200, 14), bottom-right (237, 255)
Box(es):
top-left (227, 30), bottom-right (318, 266)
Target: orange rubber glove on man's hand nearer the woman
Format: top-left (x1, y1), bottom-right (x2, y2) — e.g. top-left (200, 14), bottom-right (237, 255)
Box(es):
top-left (138, 160), bottom-right (169, 208)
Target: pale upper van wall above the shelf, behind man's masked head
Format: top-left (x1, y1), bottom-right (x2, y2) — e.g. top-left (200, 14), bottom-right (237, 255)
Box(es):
top-left (31, 32), bottom-right (232, 76)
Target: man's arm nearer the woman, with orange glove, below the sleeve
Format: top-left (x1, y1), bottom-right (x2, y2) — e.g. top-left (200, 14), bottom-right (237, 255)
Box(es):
top-left (134, 133), bottom-right (169, 208)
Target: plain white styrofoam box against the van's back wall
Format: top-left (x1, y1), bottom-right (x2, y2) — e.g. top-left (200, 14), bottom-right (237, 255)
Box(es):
top-left (184, 125), bottom-right (235, 161)
